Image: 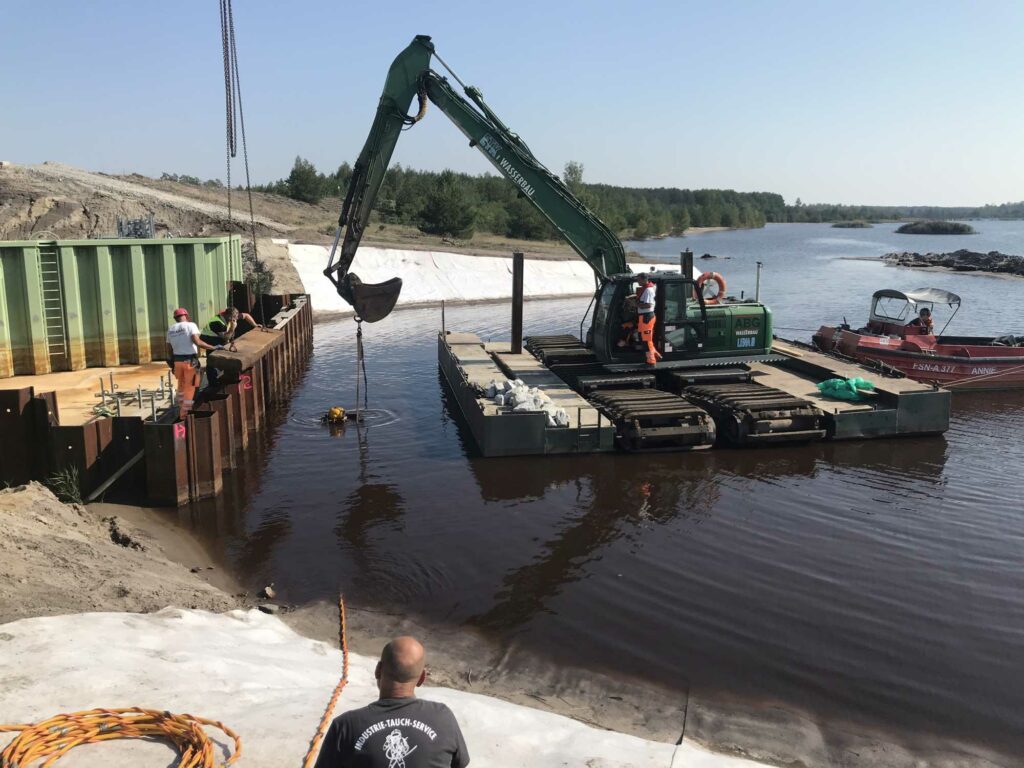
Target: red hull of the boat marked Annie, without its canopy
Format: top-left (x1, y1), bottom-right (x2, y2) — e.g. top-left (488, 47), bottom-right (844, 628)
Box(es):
top-left (813, 326), bottom-right (1024, 391)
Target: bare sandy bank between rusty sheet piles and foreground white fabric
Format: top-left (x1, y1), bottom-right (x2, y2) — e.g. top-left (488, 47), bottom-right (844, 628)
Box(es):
top-left (0, 482), bottom-right (242, 624)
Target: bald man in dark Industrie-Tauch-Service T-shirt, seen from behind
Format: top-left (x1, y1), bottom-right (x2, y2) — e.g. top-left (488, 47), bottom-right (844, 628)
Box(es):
top-left (315, 637), bottom-right (469, 768)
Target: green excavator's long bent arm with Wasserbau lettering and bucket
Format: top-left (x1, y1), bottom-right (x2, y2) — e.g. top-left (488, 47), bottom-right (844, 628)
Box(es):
top-left (324, 35), bottom-right (629, 323)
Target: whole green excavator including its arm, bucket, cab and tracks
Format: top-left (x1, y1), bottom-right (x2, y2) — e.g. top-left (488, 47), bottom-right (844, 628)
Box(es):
top-left (324, 35), bottom-right (824, 450)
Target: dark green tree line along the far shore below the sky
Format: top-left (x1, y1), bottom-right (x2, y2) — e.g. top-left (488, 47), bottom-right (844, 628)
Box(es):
top-left (162, 157), bottom-right (1024, 240)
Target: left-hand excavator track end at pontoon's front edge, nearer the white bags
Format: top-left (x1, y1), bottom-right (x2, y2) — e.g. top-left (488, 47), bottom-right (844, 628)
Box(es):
top-left (588, 389), bottom-right (715, 452)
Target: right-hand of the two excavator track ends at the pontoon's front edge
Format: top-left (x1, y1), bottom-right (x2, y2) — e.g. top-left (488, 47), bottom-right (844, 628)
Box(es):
top-left (681, 382), bottom-right (825, 445)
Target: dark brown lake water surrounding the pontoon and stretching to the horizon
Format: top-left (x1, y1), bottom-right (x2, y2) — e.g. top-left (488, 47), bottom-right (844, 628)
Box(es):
top-left (184, 222), bottom-right (1024, 765)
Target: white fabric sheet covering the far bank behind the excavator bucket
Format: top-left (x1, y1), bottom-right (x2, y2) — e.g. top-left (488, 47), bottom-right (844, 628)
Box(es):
top-left (288, 243), bottom-right (679, 312)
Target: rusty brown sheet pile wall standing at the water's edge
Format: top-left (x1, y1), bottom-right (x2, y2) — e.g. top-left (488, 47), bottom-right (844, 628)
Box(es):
top-left (0, 296), bottom-right (313, 506)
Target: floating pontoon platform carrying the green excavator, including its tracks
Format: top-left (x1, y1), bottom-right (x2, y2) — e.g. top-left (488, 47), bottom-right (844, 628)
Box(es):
top-left (437, 333), bottom-right (950, 456)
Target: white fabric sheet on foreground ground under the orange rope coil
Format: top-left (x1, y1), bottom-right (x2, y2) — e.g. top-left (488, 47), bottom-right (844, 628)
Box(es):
top-left (0, 608), bottom-right (770, 768)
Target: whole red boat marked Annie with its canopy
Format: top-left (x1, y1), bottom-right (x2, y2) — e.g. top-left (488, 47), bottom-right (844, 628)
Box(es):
top-left (813, 288), bottom-right (1024, 390)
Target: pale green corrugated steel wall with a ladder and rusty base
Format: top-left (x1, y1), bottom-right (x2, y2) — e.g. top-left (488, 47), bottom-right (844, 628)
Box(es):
top-left (0, 236), bottom-right (242, 378)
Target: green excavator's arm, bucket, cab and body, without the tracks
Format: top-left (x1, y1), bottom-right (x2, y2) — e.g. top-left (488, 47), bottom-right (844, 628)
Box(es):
top-left (324, 35), bottom-right (772, 371)
